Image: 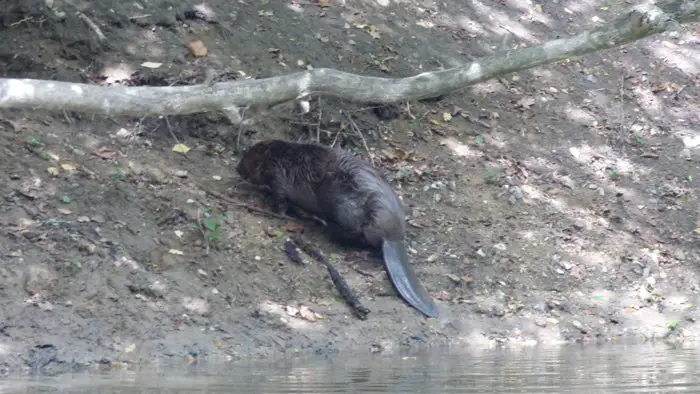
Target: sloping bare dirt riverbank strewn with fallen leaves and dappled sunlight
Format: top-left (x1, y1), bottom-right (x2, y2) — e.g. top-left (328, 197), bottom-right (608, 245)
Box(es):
top-left (0, 0), bottom-right (700, 373)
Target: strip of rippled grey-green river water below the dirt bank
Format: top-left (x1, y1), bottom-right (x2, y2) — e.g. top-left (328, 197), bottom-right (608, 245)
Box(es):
top-left (0, 345), bottom-right (700, 394)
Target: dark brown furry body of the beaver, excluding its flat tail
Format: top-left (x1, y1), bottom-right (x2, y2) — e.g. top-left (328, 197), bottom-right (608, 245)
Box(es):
top-left (237, 140), bottom-right (405, 246)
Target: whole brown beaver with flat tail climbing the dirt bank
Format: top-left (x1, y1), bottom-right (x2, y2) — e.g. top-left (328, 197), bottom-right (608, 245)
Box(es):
top-left (236, 140), bottom-right (438, 317)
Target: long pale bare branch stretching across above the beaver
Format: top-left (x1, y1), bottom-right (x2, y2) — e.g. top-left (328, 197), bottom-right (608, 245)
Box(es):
top-left (0, 0), bottom-right (700, 123)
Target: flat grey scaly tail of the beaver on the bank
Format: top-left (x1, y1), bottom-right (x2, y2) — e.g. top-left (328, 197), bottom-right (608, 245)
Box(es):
top-left (382, 240), bottom-right (439, 317)
